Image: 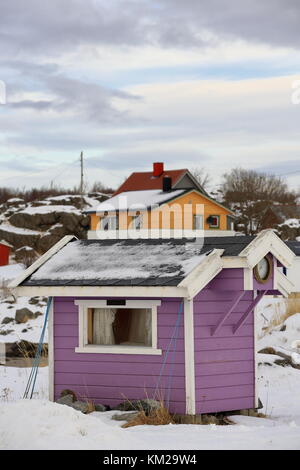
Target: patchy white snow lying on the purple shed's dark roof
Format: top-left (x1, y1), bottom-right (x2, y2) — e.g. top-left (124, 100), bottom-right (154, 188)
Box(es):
top-left (32, 240), bottom-right (209, 280)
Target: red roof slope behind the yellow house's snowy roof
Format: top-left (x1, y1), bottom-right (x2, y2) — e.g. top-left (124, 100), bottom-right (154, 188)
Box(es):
top-left (114, 169), bottom-right (188, 196)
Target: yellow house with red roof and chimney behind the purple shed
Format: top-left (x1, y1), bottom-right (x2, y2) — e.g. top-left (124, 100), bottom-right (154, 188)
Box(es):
top-left (87, 163), bottom-right (234, 239)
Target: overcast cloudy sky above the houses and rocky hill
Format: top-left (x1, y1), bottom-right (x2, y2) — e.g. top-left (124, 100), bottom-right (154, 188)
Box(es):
top-left (0, 0), bottom-right (300, 188)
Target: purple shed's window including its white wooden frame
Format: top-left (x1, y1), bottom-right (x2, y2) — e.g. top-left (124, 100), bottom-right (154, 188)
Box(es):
top-left (75, 300), bottom-right (161, 354)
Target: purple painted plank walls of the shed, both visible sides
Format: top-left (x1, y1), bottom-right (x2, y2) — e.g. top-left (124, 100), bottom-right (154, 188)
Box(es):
top-left (54, 269), bottom-right (273, 414)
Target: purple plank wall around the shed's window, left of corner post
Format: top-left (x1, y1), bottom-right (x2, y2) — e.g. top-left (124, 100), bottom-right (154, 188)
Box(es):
top-left (54, 297), bottom-right (186, 413)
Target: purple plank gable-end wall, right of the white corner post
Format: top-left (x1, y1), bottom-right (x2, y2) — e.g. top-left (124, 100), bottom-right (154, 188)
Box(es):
top-left (194, 269), bottom-right (255, 413)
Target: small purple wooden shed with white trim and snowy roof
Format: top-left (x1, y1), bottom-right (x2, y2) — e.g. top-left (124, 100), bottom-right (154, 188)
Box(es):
top-left (11, 230), bottom-right (295, 415)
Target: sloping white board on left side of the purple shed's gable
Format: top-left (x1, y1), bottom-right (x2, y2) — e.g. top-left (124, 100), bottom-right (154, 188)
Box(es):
top-left (178, 249), bottom-right (224, 299)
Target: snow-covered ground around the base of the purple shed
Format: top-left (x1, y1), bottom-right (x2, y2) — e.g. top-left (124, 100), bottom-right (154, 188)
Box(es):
top-left (0, 292), bottom-right (300, 450)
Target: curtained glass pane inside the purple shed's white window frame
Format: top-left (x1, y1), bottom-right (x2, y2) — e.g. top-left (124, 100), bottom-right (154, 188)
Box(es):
top-left (87, 308), bottom-right (152, 346)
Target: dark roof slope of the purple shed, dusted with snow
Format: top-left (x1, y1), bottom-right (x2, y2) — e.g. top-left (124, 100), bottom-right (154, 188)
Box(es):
top-left (24, 240), bottom-right (207, 285)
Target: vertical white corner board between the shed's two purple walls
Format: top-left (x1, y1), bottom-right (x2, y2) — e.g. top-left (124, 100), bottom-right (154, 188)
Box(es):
top-left (184, 299), bottom-right (196, 415)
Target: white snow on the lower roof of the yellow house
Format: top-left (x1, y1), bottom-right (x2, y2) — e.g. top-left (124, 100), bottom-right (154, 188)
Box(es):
top-left (86, 189), bottom-right (186, 213)
